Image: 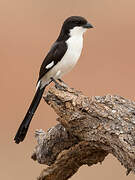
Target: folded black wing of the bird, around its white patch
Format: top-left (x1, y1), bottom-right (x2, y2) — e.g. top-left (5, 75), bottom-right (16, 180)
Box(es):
top-left (38, 41), bottom-right (67, 81)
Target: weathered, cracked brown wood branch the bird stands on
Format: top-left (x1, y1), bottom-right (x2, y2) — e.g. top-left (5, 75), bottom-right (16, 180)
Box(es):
top-left (32, 83), bottom-right (135, 180)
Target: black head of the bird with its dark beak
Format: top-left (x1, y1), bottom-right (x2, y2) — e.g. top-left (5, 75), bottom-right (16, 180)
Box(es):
top-left (58, 16), bottom-right (93, 40)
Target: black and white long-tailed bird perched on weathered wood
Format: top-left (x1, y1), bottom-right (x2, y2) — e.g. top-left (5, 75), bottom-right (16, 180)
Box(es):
top-left (14, 16), bottom-right (93, 144)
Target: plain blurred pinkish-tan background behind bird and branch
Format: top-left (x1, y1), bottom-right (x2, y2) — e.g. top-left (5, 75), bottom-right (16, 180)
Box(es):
top-left (0, 0), bottom-right (135, 180)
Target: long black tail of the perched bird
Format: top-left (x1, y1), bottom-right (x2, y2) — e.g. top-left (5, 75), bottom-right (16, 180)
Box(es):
top-left (14, 86), bottom-right (45, 144)
